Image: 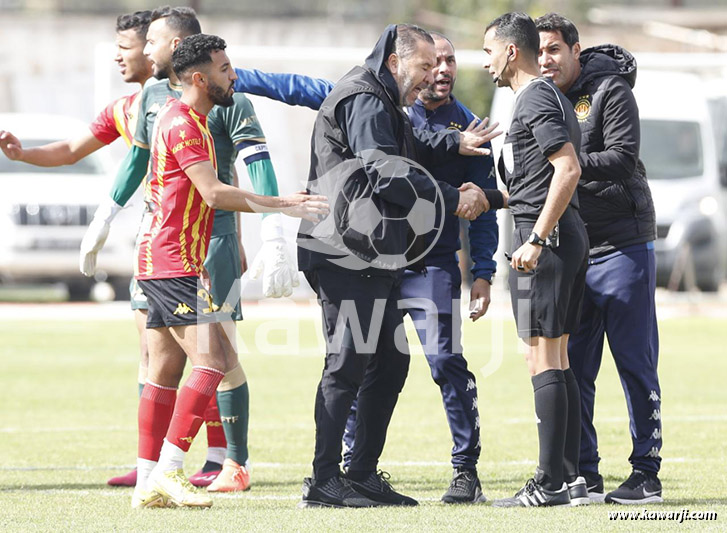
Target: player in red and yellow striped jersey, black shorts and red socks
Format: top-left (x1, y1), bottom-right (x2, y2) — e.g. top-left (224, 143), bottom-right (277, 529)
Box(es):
top-left (132, 34), bottom-right (327, 508)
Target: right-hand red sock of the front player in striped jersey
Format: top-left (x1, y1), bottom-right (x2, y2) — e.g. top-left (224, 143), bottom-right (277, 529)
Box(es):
top-left (166, 366), bottom-right (225, 450)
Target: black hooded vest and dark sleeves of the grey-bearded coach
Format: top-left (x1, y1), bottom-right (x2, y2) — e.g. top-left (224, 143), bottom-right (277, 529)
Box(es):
top-left (298, 25), bottom-right (459, 275)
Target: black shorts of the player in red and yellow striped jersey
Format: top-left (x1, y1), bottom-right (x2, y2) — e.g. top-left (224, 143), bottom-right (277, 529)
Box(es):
top-left (138, 276), bottom-right (216, 329)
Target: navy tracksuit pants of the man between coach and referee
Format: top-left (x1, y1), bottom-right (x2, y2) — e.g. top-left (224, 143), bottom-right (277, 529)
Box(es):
top-left (344, 263), bottom-right (480, 469)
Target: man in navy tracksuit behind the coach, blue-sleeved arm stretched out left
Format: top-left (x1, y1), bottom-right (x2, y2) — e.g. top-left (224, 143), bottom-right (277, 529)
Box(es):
top-left (236, 30), bottom-right (498, 503)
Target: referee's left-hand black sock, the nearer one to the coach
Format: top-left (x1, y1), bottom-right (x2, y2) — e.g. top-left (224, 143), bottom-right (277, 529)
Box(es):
top-left (531, 370), bottom-right (568, 490)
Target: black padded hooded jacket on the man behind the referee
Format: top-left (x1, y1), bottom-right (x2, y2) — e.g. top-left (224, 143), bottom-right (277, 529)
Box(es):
top-left (566, 44), bottom-right (656, 256)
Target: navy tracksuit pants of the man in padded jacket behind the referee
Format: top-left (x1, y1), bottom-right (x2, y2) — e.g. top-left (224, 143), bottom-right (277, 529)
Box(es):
top-left (568, 243), bottom-right (661, 473)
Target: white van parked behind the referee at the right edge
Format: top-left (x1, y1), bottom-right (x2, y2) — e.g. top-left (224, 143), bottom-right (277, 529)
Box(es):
top-left (490, 69), bottom-right (727, 291)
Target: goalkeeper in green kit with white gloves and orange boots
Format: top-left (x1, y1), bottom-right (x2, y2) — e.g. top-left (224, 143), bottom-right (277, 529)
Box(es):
top-left (79, 7), bottom-right (297, 492)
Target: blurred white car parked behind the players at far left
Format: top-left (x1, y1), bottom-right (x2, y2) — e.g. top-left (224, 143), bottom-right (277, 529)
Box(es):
top-left (0, 114), bottom-right (141, 299)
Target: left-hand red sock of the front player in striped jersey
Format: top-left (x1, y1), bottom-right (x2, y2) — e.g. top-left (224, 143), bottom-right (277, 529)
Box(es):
top-left (138, 382), bottom-right (177, 461)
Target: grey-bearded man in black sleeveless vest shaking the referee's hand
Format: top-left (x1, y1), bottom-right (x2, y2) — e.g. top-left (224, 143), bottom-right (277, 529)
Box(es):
top-left (298, 24), bottom-right (496, 507)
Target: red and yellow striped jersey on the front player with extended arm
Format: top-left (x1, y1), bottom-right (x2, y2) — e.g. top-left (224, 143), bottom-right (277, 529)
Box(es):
top-left (135, 98), bottom-right (217, 279)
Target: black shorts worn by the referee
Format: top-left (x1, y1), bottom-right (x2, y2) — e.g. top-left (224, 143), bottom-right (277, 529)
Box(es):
top-left (509, 206), bottom-right (588, 339)
